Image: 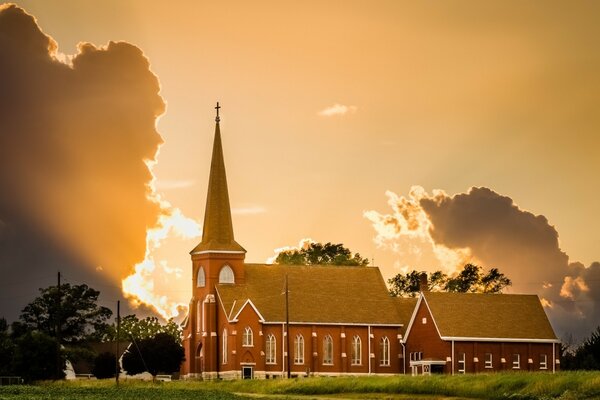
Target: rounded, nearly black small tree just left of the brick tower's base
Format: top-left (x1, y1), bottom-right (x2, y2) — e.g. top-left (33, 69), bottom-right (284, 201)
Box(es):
top-left (123, 332), bottom-right (185, 376)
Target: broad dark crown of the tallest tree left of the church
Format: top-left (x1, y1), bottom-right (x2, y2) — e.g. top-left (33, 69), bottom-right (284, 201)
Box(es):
top-left (13, 283), bottom-right (112, 343)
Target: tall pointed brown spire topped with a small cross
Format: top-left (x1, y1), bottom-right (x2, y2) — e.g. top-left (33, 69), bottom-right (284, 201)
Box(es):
top-left (191, 102), bottom-right (246, 254)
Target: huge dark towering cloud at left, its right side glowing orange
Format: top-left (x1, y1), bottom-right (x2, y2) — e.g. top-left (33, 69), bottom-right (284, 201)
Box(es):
top-left (0, 5), bottom-right (164, 322)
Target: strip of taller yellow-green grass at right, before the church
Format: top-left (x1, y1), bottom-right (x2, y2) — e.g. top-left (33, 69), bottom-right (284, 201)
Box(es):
top-left (216, 372), bottom-right (600, 400)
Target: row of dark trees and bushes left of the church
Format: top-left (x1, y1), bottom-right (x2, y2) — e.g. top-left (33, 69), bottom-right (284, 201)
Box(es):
top-left (0, 283), bottom-right (184, 382)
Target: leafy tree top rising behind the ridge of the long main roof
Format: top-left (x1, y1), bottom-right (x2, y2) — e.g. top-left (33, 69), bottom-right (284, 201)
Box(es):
top-left (275, 242), bottom-right (369, 266)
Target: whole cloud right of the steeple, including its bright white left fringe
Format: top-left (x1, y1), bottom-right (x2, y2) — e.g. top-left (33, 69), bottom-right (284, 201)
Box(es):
top-left (365, 187), bottom-right (600, 336)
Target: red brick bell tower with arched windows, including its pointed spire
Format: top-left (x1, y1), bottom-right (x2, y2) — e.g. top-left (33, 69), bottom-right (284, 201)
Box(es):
top-left (181, 103), bottom-right (246, 378)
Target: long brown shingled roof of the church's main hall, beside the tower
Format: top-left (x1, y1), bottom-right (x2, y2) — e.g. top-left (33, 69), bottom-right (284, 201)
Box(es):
top-left (217, 264), bottom-right (401, 326)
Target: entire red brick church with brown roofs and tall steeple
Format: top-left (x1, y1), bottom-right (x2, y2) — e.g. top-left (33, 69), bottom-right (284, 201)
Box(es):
top-left (181, 103), bottom-right (558, 379)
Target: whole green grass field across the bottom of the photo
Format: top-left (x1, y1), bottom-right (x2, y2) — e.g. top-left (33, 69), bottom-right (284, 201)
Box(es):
top-left (0, 372), bottom-right (600, 400)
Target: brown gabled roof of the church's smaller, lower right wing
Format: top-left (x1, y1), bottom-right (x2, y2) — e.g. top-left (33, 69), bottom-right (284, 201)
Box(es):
top-left (420, 292), bottom-right (556, 341)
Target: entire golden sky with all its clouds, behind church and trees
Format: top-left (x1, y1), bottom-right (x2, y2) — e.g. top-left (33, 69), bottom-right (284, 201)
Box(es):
top-left (0, 0), bottom-right (600, 337)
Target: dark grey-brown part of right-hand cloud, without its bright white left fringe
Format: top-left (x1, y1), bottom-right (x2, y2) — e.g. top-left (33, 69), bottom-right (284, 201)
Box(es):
top-left (420, 188), bottom-right (600, 336)
